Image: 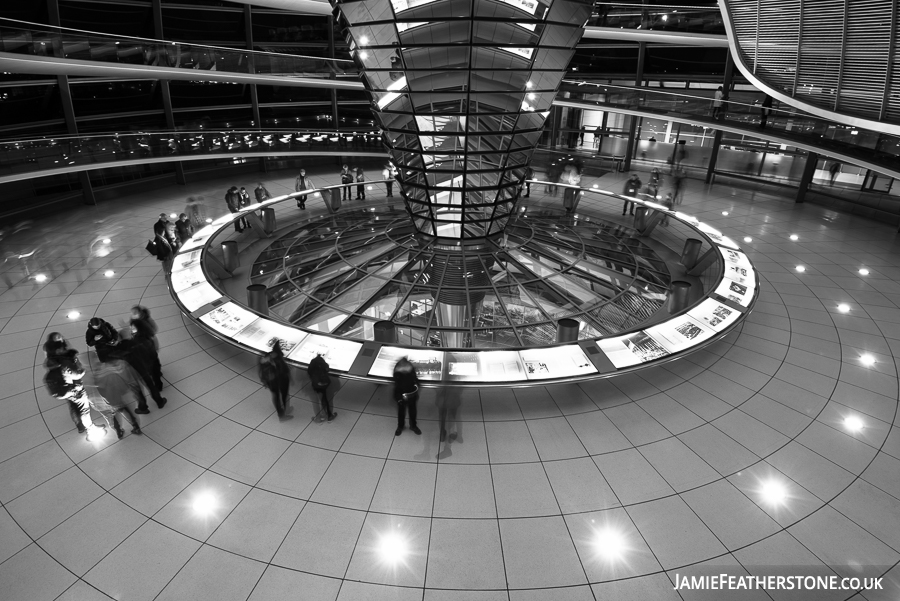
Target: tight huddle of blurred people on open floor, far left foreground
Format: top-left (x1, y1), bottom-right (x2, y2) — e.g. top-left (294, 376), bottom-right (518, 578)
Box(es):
top-left (44, 305), bottom-right (167, 440)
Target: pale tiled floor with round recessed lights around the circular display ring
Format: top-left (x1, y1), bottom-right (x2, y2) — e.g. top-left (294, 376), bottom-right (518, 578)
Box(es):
top-left (0, 165), bottom-right (900, 601)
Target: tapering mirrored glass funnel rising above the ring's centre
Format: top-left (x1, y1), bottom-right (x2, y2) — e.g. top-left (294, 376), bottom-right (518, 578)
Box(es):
top-left (332, 0), bottom-right (591, 244)
